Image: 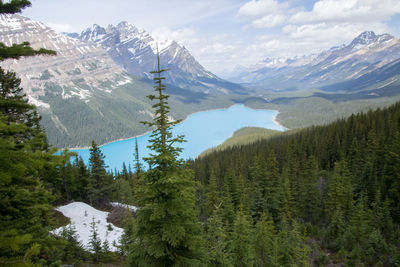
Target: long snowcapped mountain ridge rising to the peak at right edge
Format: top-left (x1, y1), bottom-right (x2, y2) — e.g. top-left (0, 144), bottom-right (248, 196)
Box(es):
top-left (232, 31), bottom-right (400, 90)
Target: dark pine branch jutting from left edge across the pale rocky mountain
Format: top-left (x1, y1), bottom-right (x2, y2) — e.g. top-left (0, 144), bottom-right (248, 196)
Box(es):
top-left (0, 42), bottom-right (56, 61)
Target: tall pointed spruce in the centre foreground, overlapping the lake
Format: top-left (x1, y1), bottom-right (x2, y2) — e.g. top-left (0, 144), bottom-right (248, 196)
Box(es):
top-left (129, 51), bottom-right (204, 266)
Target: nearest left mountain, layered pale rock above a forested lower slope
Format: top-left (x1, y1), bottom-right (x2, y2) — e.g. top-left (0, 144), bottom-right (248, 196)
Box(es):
top-left (0, 14), bottom-right (162, 147)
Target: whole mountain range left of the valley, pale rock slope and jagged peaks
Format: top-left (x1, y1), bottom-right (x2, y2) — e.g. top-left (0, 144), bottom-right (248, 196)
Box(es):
top-left (0, 14), bottom-right (243, 147)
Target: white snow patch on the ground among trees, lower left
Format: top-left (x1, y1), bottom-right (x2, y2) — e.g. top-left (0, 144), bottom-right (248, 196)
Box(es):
top-left (52, 202), bottom-right (124, 251)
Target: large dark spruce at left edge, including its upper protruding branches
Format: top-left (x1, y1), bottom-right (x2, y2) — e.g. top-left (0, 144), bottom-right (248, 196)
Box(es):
top-left (0, 0), bottom-right (55, 266)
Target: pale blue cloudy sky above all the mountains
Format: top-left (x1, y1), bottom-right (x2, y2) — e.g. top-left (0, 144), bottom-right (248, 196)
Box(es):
top-left (22, 0), bottom-right (400, 75)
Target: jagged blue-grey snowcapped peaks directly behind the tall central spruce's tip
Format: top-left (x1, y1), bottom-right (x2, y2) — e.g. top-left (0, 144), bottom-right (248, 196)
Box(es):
top-left (74, 21), bottom-right (243, 93)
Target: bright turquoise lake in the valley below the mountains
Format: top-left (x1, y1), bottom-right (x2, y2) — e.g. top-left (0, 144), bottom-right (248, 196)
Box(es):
top-left (71, 104), bottom-right (285, 171)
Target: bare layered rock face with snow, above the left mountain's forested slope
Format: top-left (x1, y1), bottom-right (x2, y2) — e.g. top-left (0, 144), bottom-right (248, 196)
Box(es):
top-left (0, 14), bottom-right (130, 108)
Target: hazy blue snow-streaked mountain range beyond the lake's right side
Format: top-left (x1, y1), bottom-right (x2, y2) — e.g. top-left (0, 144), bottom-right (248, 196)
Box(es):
top-left (230, 31), bottom-right (400, 96)
